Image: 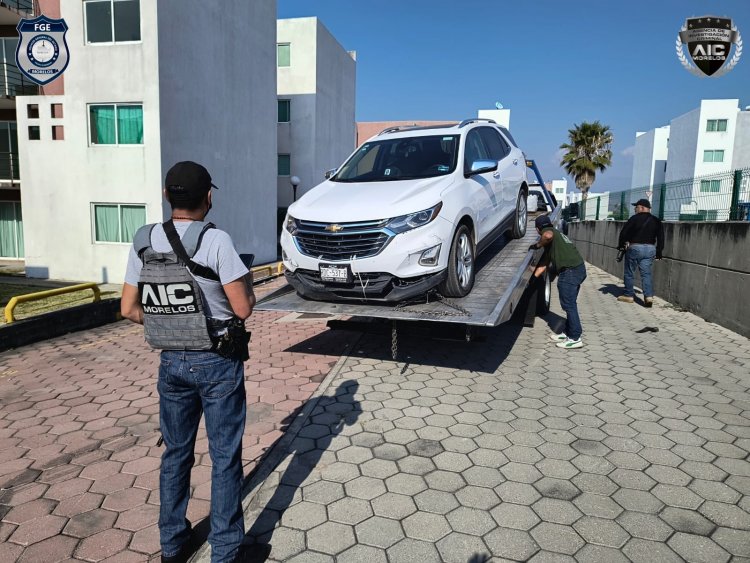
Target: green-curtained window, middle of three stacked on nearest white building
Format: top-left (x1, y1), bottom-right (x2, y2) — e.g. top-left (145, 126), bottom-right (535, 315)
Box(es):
top-left (89, 104), bottom-right (143, 145)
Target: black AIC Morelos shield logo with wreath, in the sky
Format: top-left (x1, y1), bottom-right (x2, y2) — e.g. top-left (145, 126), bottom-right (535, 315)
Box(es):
top-left (675, 16), bottom-right (742, 78)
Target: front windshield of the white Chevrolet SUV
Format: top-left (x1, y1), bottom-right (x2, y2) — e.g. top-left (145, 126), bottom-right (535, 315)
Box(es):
top-left (331, 135), bottom-right (459, 182)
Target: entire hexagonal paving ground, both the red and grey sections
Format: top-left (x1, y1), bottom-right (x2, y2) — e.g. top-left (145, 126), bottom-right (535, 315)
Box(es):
top-left (0, 267), bottom-right (750, 563)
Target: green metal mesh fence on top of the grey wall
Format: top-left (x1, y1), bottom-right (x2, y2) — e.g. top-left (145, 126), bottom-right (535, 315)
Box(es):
top-left (565, 168), bottom-right (750, 221)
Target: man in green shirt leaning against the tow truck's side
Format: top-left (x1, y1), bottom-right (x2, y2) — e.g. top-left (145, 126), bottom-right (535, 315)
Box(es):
top-left (529, 215), bottom-right (586, 350)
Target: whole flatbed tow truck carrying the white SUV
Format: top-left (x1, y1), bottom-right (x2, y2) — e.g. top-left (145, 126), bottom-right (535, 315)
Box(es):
top-left (255, 160), bottom-right (561, 360)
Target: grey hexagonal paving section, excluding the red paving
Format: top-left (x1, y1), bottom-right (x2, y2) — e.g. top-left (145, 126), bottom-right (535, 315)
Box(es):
top-left (210, 267), bottom-right (750, 563)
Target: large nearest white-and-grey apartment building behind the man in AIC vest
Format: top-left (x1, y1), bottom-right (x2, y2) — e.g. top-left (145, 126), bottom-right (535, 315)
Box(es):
top-left (17, 0), bottom-right (277, 283)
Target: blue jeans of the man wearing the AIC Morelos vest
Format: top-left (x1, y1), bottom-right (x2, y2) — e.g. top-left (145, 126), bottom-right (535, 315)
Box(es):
top-left (157, 350), bottom-right (246, 563)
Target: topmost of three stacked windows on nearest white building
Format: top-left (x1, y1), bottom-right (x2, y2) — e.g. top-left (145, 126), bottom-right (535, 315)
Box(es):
top-left (83, 0), bottom-right (141, 43)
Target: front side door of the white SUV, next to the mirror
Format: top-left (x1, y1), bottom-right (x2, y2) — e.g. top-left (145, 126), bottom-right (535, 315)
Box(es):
top-left (464, 128), bottom-right (500, 242)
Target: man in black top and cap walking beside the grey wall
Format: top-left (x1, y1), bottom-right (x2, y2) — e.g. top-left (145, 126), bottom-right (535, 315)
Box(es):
top-left (617, 199), bottom-right (664, 307)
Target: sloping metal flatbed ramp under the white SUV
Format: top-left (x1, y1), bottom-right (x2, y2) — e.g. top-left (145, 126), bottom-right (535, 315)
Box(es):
top-left (255, 221), bottom-right (542, 326)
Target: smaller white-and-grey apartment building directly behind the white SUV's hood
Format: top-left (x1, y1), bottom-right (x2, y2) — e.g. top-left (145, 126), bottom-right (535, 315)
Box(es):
top-left (274, 17), bottom-right (357, 207)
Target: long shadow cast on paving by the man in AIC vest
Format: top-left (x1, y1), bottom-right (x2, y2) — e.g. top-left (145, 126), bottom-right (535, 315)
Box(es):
top-left (239, 380), bottom-right (362, 563)
